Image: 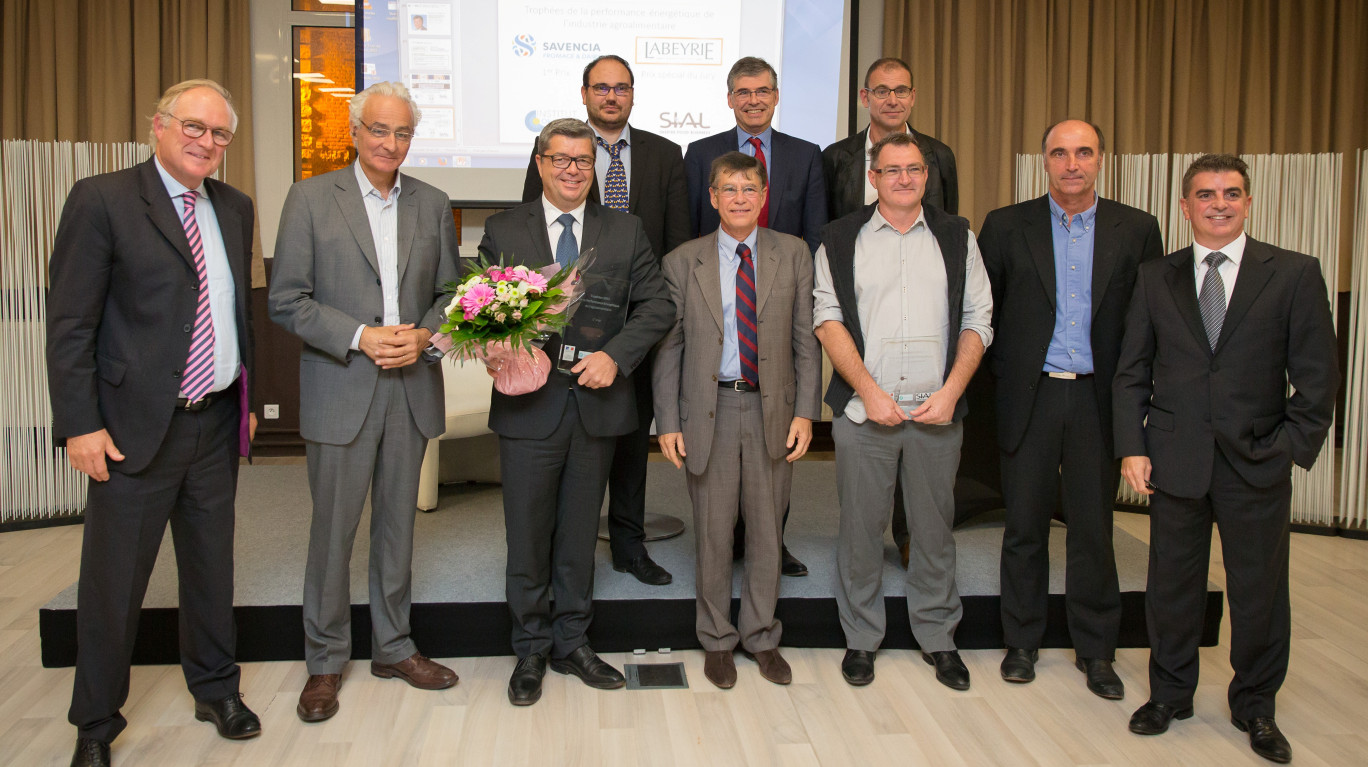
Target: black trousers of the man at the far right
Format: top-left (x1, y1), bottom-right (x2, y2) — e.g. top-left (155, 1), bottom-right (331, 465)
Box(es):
top-left (1145, 448), bottom-right (1291, 719)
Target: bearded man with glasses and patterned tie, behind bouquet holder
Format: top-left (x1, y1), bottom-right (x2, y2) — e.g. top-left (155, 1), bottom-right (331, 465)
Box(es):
top-left (523, 55), bottom-right (689, 585)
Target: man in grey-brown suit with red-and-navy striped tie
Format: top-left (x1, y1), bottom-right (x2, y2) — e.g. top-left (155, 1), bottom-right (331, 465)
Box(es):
top-left (653, 152), bottom-right (822, 689)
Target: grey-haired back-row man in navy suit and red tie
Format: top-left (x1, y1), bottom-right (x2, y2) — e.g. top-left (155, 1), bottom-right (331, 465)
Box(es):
top-left (684, 56), bottom-right (826, 576)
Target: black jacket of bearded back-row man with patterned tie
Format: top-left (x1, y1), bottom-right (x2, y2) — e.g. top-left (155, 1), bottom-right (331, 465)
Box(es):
top-left (523, 126), bottom-right (689, 258)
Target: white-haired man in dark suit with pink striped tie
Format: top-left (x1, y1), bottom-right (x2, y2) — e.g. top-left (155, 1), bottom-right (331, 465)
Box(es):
top-left (48, 79), bottom-right (261, 766)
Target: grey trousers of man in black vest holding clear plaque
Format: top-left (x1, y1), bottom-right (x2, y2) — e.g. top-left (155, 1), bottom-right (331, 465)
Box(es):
top-left (832, 416), bottom-right (963, 652)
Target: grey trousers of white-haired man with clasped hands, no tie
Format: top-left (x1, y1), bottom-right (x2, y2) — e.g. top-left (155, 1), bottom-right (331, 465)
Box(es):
top-left (304, 371), bottom-right (427, 674)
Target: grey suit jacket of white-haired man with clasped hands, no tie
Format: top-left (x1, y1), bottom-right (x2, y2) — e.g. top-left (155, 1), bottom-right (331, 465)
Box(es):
top-left (269, 165), bottom-right (457, 444)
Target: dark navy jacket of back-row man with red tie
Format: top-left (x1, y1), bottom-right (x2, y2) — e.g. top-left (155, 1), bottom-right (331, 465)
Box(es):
top-left (684, 126), bottom-right (826, 253)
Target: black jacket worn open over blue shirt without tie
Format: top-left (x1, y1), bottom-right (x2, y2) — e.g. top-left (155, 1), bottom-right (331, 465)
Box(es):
top-left (978, 196), bottom-right (1164, 453)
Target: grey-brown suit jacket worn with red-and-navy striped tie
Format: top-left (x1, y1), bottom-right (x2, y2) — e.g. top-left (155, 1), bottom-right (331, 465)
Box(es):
top-left (651, 228), bottom-right (822, 474)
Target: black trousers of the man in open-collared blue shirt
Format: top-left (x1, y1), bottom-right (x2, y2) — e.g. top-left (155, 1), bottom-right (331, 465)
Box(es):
top-left (999, 376), bottom-right (1120, 659)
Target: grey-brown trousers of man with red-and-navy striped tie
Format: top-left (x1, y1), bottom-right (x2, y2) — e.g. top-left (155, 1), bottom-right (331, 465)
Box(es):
top-left (684, 388), bottom-right (793, 652)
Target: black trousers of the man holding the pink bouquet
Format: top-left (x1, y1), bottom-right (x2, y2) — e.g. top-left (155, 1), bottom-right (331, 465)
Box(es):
top-left (499, 391), bottom-right (614, 658)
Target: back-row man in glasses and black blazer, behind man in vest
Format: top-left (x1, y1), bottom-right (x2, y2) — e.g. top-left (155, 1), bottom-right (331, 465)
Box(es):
top-left (822, 56), bottom-right (959, 218)
